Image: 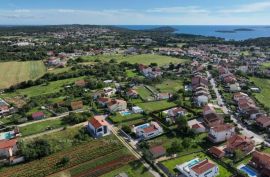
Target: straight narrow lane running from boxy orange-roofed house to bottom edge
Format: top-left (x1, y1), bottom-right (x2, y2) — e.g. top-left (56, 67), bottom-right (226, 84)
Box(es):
top-left (110, 124), bottom-right (162, 177)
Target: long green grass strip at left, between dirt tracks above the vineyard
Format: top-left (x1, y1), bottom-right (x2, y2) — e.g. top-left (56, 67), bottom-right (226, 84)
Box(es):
top-left (20, 119), bottom-right (66, 136)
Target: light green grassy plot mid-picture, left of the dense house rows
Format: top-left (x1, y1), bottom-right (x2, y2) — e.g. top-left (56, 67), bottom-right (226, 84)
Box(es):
top-left (155, 80), bottom-right (183, 93)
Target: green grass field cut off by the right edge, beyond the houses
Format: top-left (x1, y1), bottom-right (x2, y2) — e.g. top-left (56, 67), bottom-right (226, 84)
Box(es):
top-left (250, 77), bottom-right (270, 108)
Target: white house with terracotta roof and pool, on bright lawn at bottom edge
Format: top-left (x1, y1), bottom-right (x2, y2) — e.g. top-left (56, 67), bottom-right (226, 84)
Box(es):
top-left (176, 158), bottom-right (219, 177)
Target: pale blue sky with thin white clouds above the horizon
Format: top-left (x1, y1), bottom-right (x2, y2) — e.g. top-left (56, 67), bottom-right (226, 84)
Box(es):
top-left (0, 0), bottom-right (270, 25)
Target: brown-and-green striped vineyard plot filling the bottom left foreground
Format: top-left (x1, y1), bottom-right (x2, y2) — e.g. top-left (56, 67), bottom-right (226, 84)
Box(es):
top-left (0, 137), bottom-right (133, 177)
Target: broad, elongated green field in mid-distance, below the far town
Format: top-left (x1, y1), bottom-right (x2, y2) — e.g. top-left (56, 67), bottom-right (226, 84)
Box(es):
top-left (82, 54), bottom-right (186, 66)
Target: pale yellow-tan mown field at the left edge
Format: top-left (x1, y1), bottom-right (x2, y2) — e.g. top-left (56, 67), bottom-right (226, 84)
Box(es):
top-left (0, 61), bottom-right (46, 89)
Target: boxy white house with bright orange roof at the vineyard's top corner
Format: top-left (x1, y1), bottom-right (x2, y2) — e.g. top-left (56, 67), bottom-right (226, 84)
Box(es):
top-left (87, 116), bottom-right (110, 137)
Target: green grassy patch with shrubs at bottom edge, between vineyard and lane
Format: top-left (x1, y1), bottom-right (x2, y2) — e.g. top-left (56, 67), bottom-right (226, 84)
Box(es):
top-left (101, 162), bottom-right (153, 177)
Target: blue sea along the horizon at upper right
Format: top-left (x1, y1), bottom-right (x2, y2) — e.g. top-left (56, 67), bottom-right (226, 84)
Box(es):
top-left (117, 25), bottom-right (270, 41)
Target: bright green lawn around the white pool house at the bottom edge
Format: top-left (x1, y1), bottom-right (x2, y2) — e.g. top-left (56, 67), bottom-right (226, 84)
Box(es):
top-left (162, 152), bottom-right (232, 177)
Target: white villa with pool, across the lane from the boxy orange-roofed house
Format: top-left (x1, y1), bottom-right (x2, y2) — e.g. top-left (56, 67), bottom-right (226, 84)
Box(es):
top-left (134, 122), bottom-right (163, 139)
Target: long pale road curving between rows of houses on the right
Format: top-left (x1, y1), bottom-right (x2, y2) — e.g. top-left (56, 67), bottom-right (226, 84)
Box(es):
top-left (206, 71), bottom-right (266, 144)
